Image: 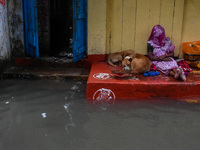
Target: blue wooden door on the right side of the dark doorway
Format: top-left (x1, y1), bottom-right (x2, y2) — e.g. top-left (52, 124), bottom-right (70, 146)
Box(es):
top-left (73, 0), bottom-right (87, 62)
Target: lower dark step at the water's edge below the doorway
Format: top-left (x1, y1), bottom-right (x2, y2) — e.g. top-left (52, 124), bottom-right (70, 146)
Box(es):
top-left (3, 66), bottom-right (90, 80)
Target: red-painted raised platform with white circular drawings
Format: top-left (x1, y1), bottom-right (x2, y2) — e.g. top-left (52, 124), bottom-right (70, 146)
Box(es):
top-left (87, 62), bottom-right (200, 100)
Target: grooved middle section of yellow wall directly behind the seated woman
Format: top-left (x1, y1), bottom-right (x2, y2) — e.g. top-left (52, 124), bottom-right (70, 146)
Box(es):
top-left (107, 0), bottom-right (184, 56)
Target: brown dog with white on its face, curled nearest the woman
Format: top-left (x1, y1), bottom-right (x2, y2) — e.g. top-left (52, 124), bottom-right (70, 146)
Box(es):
top-left (122, 54), bottom-right (151, 73)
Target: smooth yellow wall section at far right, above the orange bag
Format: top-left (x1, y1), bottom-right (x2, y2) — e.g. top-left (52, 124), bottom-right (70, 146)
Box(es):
top-left (182, 0), bottom-right (200, 42)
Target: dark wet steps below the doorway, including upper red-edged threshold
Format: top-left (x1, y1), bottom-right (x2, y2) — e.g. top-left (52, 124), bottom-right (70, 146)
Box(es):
top-left (0, 57), bottom-right (90, 80)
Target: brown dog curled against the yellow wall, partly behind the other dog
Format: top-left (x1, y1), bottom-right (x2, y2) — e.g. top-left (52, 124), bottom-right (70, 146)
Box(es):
top-left (107, 50), bottom-right (135, 67)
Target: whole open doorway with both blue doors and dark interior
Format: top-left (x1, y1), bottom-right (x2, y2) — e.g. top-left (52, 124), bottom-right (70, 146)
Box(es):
top-left (23, 0), bottom-right (87, 62)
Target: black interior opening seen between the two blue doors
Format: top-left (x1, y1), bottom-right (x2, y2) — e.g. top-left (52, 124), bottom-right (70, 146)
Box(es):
top-left (50, 0), bottom-right (73, 57)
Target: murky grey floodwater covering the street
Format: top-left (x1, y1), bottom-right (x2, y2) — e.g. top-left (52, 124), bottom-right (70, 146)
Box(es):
top-left (0, 79), bottom-right (200, 150)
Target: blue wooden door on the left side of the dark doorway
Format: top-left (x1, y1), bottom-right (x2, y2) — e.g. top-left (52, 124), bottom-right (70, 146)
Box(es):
top-left (23, 0), bottom-right (39, 58)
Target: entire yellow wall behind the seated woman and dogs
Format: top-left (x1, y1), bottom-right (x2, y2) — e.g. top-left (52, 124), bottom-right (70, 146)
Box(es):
top-left (88, 0), bottom-right (200, 56)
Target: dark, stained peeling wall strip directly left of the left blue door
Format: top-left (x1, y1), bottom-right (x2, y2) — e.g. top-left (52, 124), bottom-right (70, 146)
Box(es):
top-left (7, 0), bottom-right (25, 57)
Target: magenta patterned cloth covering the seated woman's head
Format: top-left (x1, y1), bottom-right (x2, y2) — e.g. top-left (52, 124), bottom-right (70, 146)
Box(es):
top-left (148, 25), bottom-right (167, 47)
